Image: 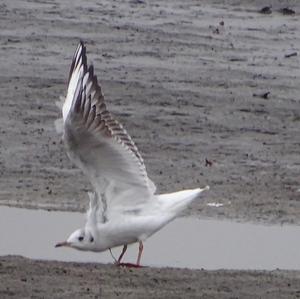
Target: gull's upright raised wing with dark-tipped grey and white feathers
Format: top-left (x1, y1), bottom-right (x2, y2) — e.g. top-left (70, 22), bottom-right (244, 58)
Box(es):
top-left (63, 42), bottom-right (155, 218)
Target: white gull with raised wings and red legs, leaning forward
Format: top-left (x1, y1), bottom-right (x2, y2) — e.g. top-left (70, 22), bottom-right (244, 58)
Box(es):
top-left (55, 42), bottom-right (209, 266)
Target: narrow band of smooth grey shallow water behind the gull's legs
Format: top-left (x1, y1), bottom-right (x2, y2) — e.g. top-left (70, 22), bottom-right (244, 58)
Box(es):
top-left (0, 207), bottom-right (300, 270)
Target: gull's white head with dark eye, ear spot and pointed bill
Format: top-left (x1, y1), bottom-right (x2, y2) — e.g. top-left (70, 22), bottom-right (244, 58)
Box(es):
top-left (55, 228), bottom-right (95, 250)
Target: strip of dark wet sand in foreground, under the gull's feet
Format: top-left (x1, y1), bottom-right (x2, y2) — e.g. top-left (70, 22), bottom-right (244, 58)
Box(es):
top-left (0, 256), bottom-right (300, 299)
